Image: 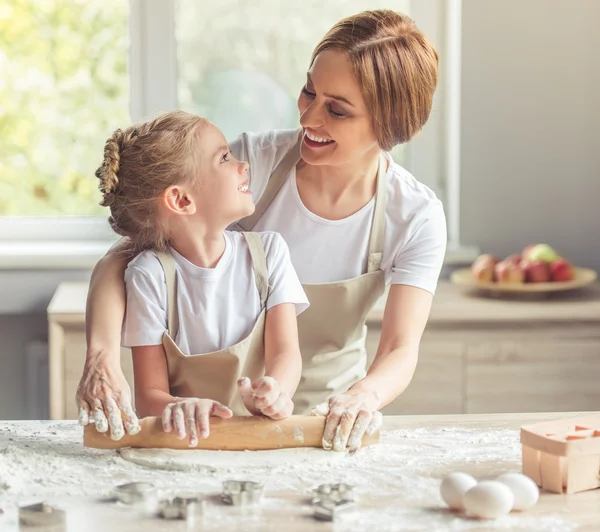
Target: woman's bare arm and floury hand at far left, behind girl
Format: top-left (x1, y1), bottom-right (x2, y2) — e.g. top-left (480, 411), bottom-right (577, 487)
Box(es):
top-left (76, 239), bottom-right (140, 440)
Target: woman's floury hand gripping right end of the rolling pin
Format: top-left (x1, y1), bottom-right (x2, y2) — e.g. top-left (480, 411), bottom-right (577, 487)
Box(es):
top-left (313, 389), bottom-right (382, 452)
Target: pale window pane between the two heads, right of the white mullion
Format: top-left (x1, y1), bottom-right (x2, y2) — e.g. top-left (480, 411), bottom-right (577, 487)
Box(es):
top-left (175, 0), bottom-right (411, 168)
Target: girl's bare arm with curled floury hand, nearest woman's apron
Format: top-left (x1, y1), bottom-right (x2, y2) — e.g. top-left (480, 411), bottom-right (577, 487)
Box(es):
top-left (240, 303), bottom-right (302, 419)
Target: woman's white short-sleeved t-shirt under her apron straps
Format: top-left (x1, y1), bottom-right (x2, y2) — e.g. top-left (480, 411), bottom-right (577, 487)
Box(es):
top-left (230, 130), bottom-right (447, 293)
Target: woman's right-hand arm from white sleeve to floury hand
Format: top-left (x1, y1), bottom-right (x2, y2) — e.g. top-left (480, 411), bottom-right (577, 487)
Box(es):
top-left (323, 199), bottom-right (448, 451)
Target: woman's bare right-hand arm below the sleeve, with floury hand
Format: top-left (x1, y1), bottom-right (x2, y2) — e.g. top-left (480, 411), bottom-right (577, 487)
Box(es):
top-left (323, 284), bottom-right (433, 451)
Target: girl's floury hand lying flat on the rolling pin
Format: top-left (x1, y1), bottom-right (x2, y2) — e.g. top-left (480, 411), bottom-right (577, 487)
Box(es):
top-left (162, 397), bottom-right (233, 447)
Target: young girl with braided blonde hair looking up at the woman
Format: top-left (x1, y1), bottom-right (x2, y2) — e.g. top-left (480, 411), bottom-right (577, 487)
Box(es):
top-left (94, 111), bottom-right (308, 447)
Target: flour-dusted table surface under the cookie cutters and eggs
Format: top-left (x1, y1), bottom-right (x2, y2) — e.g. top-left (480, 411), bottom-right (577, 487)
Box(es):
top-left (0, 412), bottom-right (600, 532)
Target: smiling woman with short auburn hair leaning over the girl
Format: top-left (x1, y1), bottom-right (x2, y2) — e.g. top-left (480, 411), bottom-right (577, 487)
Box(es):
top-left (77, 10), bottom-right (446, 451)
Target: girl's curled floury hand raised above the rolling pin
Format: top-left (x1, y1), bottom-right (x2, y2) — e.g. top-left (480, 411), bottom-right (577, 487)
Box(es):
top-left (238, 377), bottom-right (294, 419)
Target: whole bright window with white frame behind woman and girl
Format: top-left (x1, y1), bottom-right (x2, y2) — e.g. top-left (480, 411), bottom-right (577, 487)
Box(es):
top-left (0, 0), bottom-right (460, 254)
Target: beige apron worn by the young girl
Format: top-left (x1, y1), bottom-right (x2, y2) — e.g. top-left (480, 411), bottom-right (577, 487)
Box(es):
top-left (157, 233), bottom-right (269, 416)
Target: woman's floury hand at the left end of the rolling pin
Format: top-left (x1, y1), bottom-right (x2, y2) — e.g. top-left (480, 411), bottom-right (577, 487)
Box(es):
top-left (76, 355), bottom-right (140, 440)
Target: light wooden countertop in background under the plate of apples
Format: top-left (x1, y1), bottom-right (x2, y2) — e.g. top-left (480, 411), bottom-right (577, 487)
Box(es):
top-left (48, 281), bottom-right (600, 328)
